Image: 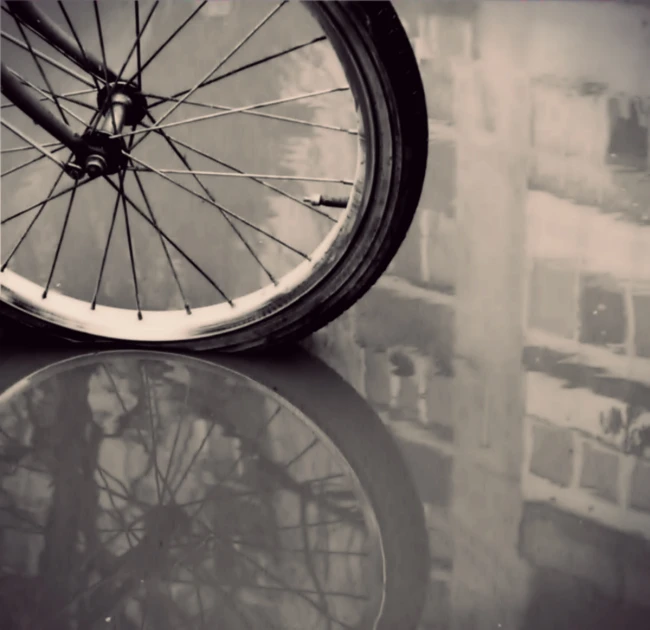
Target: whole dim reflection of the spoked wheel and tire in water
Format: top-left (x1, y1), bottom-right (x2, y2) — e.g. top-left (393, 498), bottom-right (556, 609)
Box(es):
top-left (0, 351), bottom-right (428, 630)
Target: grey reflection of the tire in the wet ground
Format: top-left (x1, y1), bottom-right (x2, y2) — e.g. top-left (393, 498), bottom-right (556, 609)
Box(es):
top-left (0, 349), bottom-right (429, 630)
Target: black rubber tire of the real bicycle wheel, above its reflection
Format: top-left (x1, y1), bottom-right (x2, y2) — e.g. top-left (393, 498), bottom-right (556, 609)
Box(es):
top-left (0, 1), bottom-right (428, 352)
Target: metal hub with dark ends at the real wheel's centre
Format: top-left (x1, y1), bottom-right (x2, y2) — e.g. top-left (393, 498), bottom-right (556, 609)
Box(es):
top-left (69, 82), bottom-right (147, 178)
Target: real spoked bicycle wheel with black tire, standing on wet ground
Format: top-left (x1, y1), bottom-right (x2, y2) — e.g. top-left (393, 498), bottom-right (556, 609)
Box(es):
top-left (0, 0), bottom-right (428, 351)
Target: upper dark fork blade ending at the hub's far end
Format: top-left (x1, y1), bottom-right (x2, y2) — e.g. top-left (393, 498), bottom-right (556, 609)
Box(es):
top-left (7, 0), bottom-right (117, 83)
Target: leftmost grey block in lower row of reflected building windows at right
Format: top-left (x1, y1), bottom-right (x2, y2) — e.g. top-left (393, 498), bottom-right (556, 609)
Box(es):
top-left (530, 424), bottom-right (573, 487)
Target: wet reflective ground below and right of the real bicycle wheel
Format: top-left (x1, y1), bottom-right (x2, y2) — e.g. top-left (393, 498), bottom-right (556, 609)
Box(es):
top-left (0, 0), bottom-right (650, 630)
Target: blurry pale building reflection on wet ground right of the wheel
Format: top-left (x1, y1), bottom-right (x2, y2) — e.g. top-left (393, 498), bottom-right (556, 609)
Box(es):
top-left (309, 1), bottom-right (650, 629)
